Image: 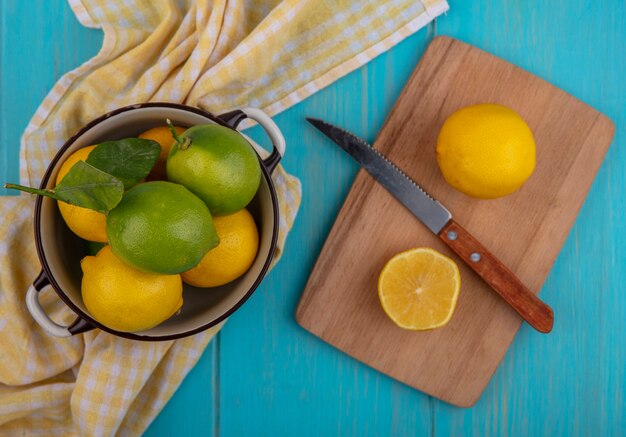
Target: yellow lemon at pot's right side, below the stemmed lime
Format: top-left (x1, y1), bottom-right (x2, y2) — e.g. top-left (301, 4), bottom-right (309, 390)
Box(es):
top-left (182, 209), bottom-right (259, 287)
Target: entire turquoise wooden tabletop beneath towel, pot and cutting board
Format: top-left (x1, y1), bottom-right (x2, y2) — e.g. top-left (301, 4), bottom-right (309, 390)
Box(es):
top-left (0, 0), bottom-right (626, 436)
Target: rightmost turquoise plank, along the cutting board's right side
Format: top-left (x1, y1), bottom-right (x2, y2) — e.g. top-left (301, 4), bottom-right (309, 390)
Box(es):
top-left (433, 0), bottom-right (626, 436)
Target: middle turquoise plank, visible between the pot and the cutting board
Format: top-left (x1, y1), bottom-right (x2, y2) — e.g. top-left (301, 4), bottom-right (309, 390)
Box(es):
top-left (220, 30), bottom-right (432, 436)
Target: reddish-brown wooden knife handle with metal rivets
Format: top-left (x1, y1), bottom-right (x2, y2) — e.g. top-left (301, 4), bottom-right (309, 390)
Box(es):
top-left (439, 220), bottom-right (554, 333)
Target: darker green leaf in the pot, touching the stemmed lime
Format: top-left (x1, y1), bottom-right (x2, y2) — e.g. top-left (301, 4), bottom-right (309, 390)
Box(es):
top-left (87, 138), bottom-right (161, 190)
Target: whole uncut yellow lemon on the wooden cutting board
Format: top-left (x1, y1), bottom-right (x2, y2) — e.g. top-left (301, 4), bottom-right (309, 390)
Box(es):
top-left (436, 104), bottom-right (535, 199)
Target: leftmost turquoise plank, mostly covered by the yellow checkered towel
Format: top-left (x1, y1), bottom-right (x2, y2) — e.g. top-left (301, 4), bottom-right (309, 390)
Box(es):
top-left (0, 0), bottom-right (218, 436)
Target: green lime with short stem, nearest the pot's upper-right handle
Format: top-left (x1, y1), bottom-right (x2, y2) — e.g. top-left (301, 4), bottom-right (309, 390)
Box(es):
top-left (166, 124), bottom-right (261, 215)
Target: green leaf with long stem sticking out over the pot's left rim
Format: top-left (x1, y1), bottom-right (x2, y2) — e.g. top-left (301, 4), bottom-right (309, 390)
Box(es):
top-left (4, 161), bottom-right (124, 212)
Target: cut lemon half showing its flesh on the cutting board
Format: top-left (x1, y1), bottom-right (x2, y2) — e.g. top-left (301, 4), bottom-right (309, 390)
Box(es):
top-left (378, 248), bottom-right (461, 331)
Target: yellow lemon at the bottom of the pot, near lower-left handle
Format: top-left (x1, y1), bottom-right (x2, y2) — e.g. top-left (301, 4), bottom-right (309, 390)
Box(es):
top-left (80, 246), bottom-right (183, 332)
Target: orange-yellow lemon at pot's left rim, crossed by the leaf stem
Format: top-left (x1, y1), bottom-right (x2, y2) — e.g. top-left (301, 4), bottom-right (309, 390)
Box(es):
top-left (56, 146), bottom-right (107, 243)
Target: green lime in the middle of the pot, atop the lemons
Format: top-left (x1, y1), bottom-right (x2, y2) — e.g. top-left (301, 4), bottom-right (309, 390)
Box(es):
top-left (107, 181), bottom-right (219, 274)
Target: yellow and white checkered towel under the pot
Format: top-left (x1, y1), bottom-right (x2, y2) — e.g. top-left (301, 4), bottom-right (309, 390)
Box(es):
top-left (0, 0), bottom-right (447, 436)
